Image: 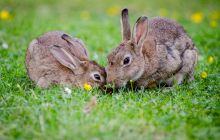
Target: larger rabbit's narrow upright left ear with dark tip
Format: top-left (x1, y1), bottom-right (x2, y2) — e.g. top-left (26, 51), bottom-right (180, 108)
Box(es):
top-left (121, 8), bottom-right (131, 41)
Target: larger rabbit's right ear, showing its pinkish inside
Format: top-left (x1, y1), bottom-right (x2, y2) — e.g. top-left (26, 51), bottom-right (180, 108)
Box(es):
top-left (132, 16), bottom-right (148, 46)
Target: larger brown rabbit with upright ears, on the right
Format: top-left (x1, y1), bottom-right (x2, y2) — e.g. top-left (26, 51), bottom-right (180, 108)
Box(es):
top-left (106, 9), bottom-right (198, 87)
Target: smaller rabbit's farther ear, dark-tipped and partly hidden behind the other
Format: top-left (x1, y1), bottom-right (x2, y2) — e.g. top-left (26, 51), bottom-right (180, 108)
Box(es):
top-left (61, 34), bottom-right (88, 58)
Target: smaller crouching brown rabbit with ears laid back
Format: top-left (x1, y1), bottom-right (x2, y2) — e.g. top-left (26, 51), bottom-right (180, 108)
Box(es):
top-left (26, 31), bottom-right (106, 88)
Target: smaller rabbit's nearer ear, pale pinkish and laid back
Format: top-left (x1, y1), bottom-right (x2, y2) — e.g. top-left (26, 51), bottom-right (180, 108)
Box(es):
top-left (50, 45), bottom-right (81, 71)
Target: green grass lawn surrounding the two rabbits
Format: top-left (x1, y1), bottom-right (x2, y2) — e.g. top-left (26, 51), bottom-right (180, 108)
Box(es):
top-left (0, 0), bottom-right (220, 140)
